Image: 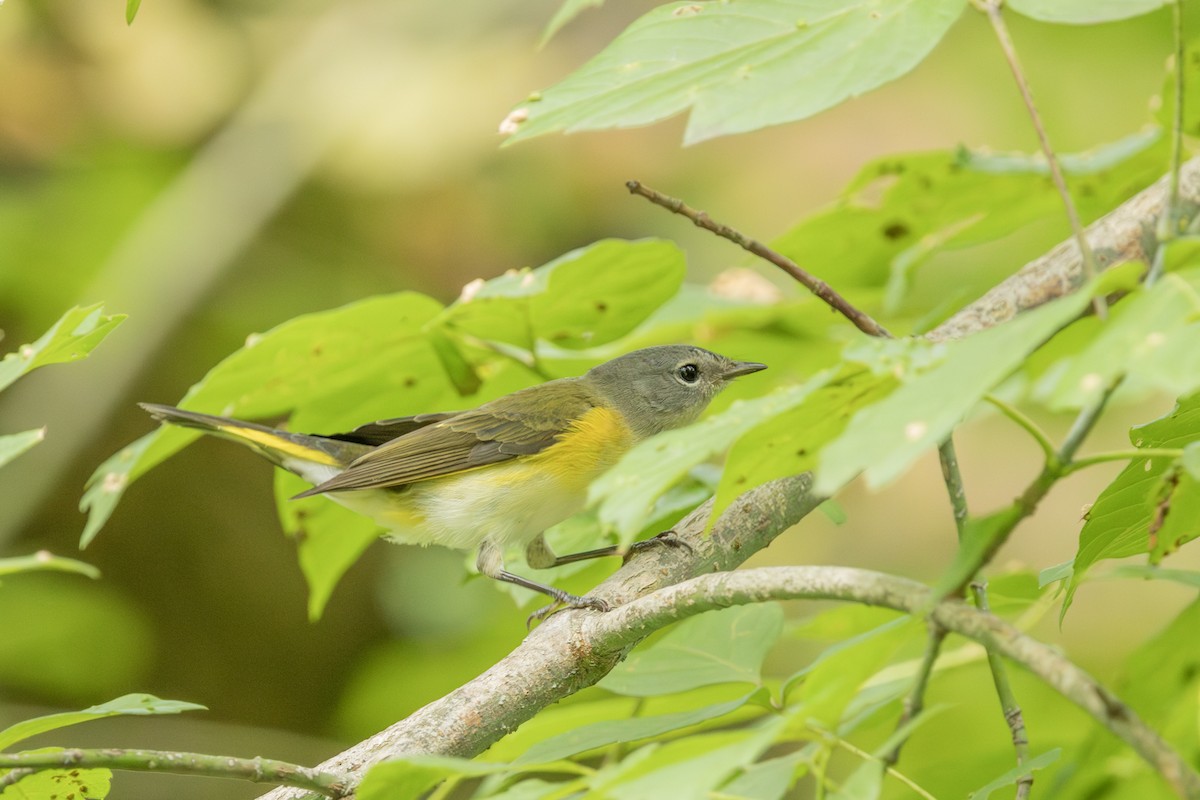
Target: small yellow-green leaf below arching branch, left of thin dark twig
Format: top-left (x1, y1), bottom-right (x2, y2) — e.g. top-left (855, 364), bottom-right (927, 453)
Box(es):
top-left (784, 618), bottom-right (919, 729)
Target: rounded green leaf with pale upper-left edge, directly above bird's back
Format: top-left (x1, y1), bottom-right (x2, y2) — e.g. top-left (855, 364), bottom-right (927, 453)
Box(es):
top-left (438, 239), bottom-right (686, 353)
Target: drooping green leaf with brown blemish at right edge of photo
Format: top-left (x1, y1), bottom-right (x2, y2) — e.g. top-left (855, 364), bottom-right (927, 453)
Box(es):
top-left (1060, 395), bottom-right (1200, 616)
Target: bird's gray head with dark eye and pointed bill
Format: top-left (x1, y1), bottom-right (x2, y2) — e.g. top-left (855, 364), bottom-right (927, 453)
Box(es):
top-left (587, 344), bottom-right (767, 439)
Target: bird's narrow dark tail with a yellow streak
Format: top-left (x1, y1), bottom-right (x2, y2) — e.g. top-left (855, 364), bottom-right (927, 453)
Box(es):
top-left (138, 403), bottom-right (371, 483)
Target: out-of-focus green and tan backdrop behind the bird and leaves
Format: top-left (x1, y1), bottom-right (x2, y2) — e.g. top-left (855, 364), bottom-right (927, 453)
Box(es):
top-left (0, 0), bottom-right (1189, 798)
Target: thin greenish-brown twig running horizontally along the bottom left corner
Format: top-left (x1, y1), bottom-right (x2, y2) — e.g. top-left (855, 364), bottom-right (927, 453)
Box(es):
top-left (0, 748), bottom-right (350, 798)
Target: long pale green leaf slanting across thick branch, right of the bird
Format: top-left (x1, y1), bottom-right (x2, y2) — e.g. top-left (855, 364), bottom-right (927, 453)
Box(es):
top-left (815, 270), bottom-right (1132, 494)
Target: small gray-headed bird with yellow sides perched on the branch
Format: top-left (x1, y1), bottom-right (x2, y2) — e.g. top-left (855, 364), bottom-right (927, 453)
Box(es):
top-left (142, 345), bottom-right (767, 610)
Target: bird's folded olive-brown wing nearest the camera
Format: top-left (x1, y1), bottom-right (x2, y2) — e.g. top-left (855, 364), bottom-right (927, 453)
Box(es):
top-left (299, 379), bottom-right (596, 497)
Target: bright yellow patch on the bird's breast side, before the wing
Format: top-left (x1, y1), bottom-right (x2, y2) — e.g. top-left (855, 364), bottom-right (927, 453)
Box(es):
top-left (522, 408), bottom-right (634, 492)
